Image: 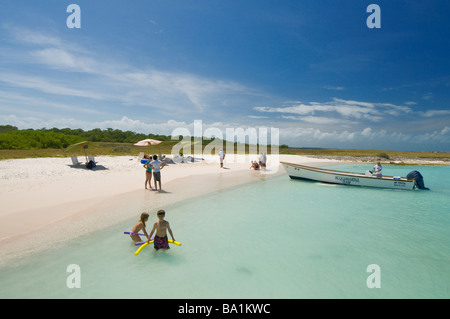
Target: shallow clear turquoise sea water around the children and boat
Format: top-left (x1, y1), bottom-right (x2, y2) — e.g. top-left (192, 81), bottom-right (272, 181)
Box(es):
top-left (0, 165), bottom-right (450, 298)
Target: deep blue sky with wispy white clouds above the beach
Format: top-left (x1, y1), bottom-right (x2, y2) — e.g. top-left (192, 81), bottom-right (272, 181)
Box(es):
top-left (0, 0), bottom-right (450, 151)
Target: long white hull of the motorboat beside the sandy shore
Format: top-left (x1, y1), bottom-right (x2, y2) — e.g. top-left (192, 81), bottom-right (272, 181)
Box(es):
top-left (281, 162), bottom-right (415, 190)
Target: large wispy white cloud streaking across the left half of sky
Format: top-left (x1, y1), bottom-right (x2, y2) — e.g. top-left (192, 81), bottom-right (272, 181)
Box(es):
top-left (0, 26), bottom-right (264, 116)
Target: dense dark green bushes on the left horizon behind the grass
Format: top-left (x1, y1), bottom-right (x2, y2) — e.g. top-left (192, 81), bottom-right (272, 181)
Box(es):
top-left (0, 125), bottom-right (171, 150)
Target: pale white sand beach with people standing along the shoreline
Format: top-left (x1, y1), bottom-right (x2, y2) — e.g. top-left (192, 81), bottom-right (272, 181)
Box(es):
top-left (0, 155), bottom-right (337, 261)
